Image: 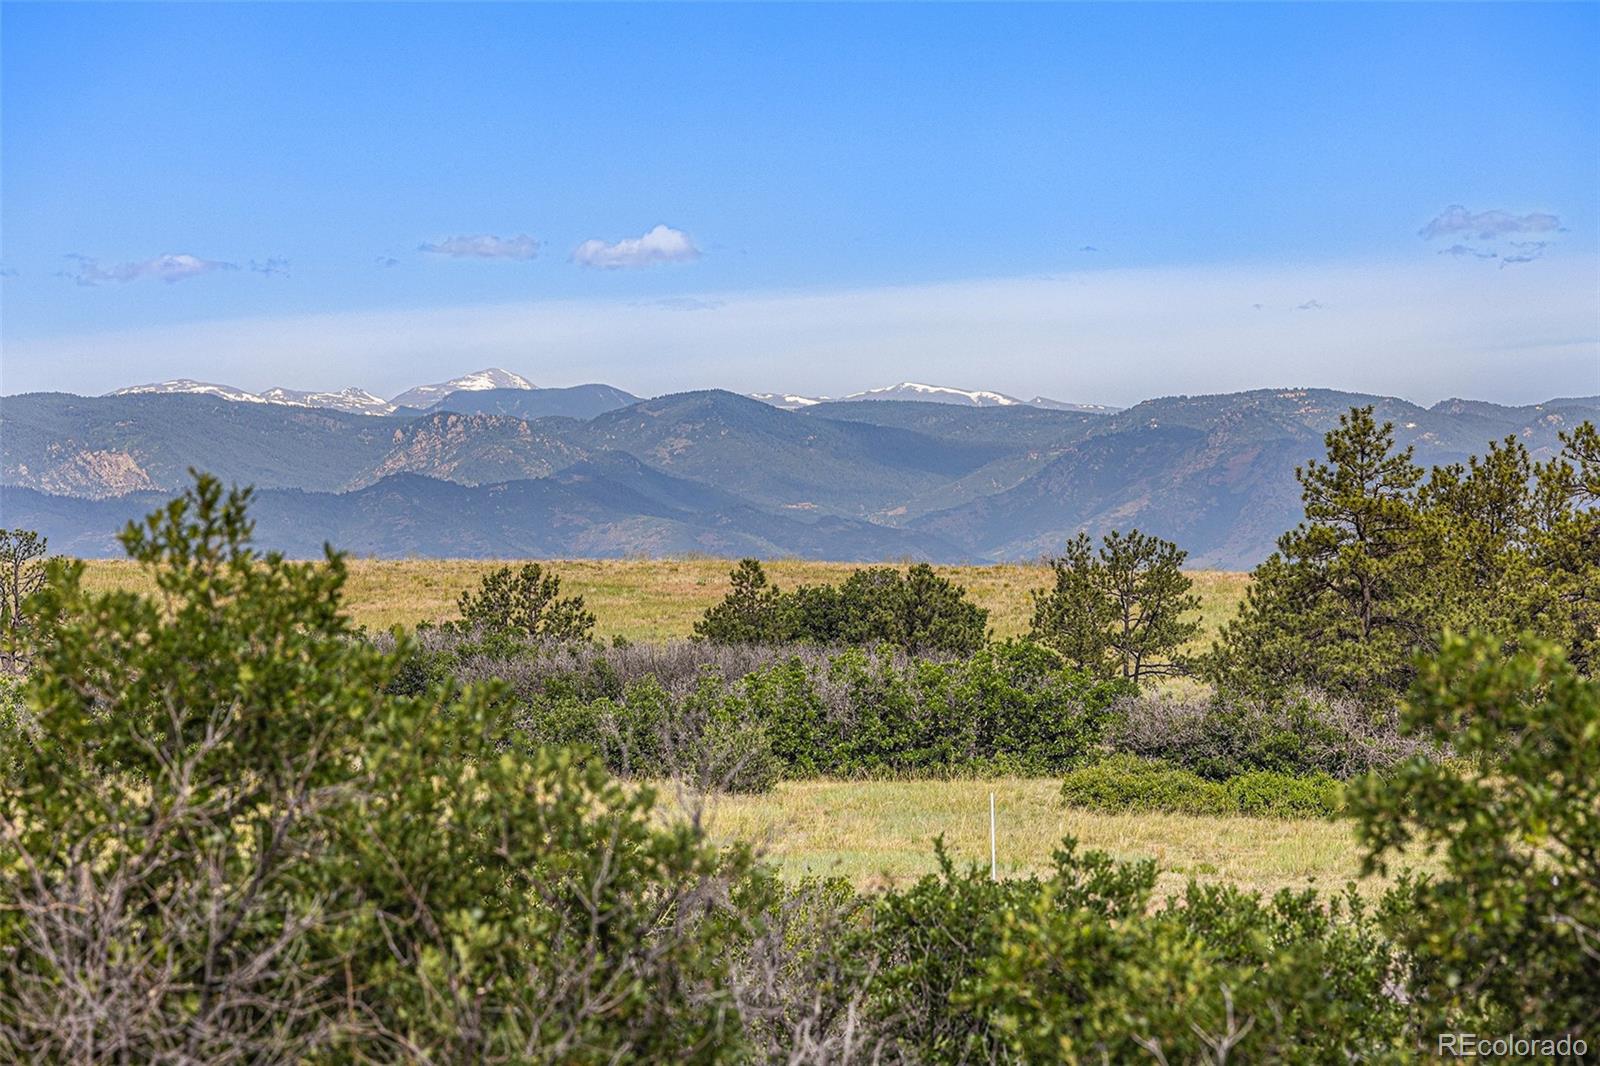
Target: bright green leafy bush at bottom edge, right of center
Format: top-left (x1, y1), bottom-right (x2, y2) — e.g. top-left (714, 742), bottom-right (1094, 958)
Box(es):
top-left (845, 840), bottom-right (1416, 1063)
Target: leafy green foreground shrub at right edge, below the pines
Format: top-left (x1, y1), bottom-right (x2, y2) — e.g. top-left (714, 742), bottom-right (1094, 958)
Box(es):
top-left (1352, 635), bottom-right (1600, 1040)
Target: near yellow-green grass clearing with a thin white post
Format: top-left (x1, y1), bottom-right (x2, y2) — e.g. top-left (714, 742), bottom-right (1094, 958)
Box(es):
top-left (675, 778), bottom-right (1379, 895)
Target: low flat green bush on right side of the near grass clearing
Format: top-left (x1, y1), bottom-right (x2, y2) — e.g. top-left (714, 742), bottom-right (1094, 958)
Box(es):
top-left (1061, 755), bottom-right (1344, 818)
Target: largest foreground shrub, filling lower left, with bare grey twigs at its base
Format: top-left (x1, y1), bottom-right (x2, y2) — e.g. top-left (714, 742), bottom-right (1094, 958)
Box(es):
top-left (0, 477), bottom-right (760, 1063)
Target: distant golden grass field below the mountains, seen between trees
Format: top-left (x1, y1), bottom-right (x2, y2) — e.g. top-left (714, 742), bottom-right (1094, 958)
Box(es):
top-left (78, 559), bottom-right (1246, 642)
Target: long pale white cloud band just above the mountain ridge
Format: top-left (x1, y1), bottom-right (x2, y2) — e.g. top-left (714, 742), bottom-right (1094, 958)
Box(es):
top-left (15, 253), bottom-right (1600, 403)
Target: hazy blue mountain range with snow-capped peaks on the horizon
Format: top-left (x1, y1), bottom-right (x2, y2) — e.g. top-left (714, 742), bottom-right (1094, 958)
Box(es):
top-left (0, 371), bottom-right (1600, 568)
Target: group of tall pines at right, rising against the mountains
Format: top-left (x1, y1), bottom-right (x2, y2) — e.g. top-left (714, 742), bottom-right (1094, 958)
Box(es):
top-left (1205, 407), bottom-right (1600, 703)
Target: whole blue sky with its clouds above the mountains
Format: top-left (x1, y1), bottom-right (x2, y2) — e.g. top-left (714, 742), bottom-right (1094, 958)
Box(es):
top-left (0, 3), bottom-right (1600, 403)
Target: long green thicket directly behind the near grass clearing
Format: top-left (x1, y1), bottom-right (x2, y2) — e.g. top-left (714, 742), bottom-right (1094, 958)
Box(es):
top-left (518, 643), bottom-right (1126, 791)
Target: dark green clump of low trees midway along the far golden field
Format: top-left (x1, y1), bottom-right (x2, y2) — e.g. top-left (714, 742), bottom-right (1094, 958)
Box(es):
top-left (694, 559), bottom-right (989, 655)
